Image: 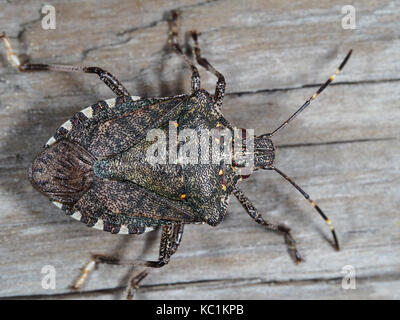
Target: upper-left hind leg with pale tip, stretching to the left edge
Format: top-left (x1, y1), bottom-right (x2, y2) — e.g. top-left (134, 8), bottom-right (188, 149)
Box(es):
top-left (0, 32), bottom-right (129, 96)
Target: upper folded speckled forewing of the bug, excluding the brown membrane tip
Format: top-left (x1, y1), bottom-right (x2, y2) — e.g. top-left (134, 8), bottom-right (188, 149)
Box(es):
top-left (66, 96), bottom-right (186, 158)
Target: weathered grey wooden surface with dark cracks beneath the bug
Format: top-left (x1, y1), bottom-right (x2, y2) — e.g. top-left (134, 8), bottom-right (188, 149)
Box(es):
top-left (0, 0), bottom-right (400, 299)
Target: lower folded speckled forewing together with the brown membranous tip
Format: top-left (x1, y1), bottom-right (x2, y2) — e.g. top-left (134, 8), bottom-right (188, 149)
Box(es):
top-left (29, 139), bottom-right (201, 234)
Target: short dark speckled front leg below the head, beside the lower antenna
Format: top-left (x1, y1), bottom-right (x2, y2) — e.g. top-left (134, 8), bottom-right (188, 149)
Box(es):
top-left (233, 187), bottom-right (303, 263)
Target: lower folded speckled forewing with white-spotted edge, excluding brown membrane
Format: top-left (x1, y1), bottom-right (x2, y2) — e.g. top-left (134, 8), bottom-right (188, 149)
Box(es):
top-left (66, 176), bottom-right (200, 234)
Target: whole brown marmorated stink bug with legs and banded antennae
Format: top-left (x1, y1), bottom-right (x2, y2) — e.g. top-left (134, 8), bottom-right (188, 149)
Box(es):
top-left (0, 11), bottom-right (352, 298)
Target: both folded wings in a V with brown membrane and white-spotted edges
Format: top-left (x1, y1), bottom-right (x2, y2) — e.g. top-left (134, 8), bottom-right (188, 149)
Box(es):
top-left (29, 95), bottom-right (201, 234)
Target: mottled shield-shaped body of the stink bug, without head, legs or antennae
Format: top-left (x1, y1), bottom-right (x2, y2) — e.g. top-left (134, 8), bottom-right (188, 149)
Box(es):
top-left (29, 90), bottom-right (258, 234)
